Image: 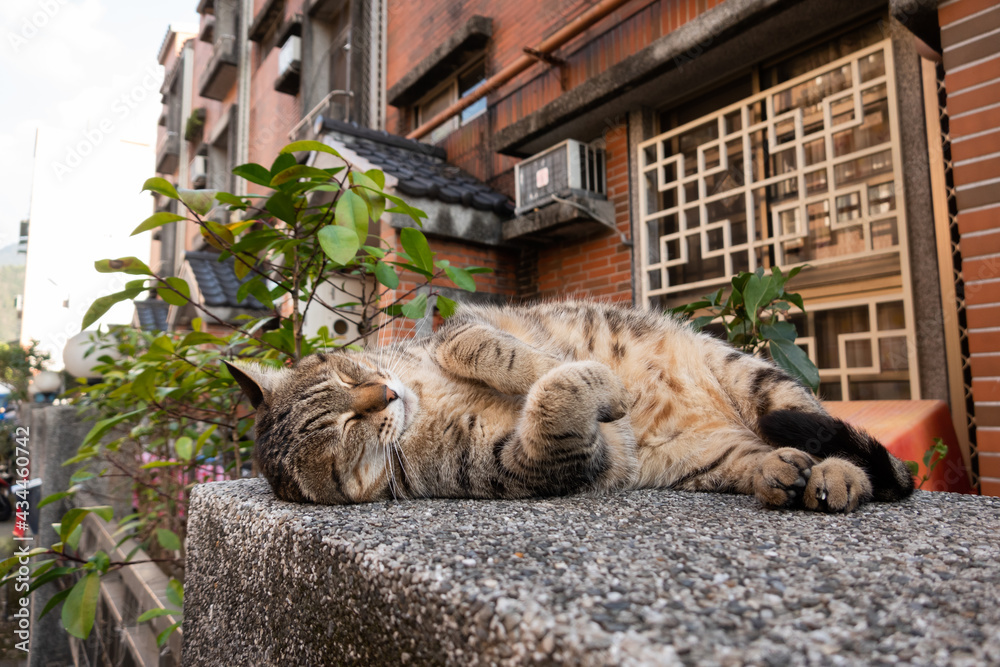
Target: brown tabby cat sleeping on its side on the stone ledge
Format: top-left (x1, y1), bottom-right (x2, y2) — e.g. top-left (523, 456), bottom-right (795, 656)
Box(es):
top-left (227, 302), bottom-right (913, 512)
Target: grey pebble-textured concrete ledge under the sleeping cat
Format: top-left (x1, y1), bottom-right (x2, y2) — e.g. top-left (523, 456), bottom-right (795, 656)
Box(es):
top-left (184, 480), bottom-right (1000, 665)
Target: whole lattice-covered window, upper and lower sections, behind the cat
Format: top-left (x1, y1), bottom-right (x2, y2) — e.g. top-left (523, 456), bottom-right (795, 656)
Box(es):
top-left (637, 31), bottom-right (919, 400)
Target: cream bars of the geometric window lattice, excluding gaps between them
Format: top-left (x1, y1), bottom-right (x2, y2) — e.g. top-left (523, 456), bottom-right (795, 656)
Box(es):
top-left (636, 40), bottom-right (920, 400)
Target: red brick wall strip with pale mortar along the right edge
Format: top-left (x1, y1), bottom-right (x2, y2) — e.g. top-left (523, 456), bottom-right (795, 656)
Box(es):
top-left (938, 0), bottom-right (1000, 495)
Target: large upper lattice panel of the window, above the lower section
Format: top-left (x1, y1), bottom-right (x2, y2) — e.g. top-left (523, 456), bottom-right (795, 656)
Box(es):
top-left (639, 42), bottom-right (904, 306)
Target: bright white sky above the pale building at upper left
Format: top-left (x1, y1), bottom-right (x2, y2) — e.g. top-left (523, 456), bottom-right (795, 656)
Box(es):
top-left (0, 0), bottom-right (198, 247)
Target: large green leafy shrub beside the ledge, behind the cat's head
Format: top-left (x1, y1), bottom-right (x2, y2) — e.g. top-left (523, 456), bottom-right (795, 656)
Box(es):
top-left (0, 141), bottom-right (488, 645)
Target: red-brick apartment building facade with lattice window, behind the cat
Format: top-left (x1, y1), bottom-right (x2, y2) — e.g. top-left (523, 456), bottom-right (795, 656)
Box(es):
top-left (154, 0), bottom-right (1000, 494)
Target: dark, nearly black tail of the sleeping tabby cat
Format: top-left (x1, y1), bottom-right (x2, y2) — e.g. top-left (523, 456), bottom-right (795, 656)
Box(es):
top-left (759, 410), bottom-right (913, 501)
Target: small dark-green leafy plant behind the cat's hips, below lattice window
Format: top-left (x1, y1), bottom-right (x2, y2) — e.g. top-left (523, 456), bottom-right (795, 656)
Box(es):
top-left (670, 266), bottom-right (819, 391)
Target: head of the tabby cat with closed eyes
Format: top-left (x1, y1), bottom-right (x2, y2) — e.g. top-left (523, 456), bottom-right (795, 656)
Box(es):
top-left (226, 352), bottom-right (417, 505)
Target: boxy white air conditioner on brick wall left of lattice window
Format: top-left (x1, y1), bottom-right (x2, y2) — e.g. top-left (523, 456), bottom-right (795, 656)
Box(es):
top-left (514, 139), bottom-right (606, 215)
